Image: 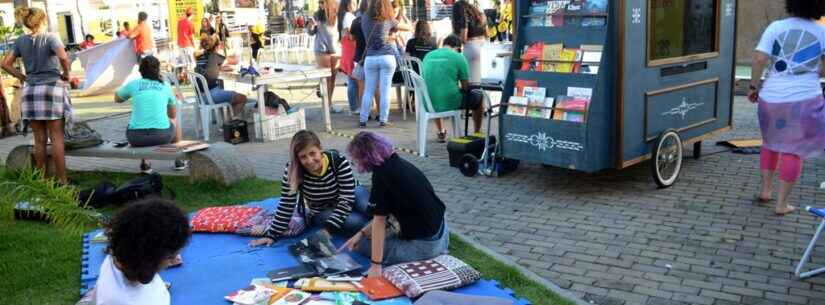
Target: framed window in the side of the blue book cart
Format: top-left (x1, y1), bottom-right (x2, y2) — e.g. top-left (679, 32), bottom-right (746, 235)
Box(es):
top-left (647, 0), bottom-right (719, 65)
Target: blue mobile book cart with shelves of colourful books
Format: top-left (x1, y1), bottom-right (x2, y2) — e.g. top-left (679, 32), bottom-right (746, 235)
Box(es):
top-left (466, 0), bottom-right (736, 187)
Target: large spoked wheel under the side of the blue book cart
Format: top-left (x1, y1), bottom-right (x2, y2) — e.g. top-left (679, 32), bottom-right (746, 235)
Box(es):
top-left (650, 130), bottom-right (683, 188)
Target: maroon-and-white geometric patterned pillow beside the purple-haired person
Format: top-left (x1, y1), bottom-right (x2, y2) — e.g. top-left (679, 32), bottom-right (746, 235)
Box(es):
top-left (384, 255), bottom-right (481, 298)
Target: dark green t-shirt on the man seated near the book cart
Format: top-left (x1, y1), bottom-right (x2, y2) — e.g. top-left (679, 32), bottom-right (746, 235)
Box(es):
top-left (422, 48), bottom-right (469, 112)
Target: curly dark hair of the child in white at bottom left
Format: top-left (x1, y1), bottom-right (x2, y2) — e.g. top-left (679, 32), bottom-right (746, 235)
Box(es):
top-left (106, 198), bottom-right (192, 284)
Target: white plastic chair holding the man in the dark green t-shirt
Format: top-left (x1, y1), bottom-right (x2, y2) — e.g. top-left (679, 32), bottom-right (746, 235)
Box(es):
top-left (407, 71), bottom-right (461, 157)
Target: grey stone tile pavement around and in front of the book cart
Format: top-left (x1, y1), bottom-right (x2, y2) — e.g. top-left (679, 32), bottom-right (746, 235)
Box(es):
top-left (0, 95), bottom-right (825, 305)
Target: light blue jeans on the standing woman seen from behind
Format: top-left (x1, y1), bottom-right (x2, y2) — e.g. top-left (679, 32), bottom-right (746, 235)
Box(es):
top-left (360, 55), bottom-right (397, 123)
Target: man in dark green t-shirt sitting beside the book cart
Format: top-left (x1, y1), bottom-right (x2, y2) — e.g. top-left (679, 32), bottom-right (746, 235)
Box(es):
top-left (422, 35), bottom-right (484, 143)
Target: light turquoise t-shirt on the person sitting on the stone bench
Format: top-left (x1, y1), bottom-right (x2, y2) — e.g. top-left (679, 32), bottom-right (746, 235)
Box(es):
top-left (117, 78), bottom-right (175, 129)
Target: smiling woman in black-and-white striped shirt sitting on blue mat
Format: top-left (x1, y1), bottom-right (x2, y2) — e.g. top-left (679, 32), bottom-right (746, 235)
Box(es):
top-left (250, 130), bottom-right (369, 246)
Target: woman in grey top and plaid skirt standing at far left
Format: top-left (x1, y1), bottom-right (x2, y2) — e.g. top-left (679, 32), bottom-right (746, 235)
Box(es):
top-left (2, 7), bottom-right (71, 184)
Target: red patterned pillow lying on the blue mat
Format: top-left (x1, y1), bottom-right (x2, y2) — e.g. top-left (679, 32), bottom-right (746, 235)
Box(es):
top-left (190, 206), bottom-right (264, 233)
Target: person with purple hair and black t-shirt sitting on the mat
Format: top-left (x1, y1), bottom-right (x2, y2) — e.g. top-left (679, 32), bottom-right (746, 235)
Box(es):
top-left (339, 131), bottom-right (450, 277)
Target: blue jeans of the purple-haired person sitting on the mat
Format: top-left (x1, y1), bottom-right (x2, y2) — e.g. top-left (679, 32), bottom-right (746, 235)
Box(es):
top-left (355, 217), bottom-right (450, 266)
